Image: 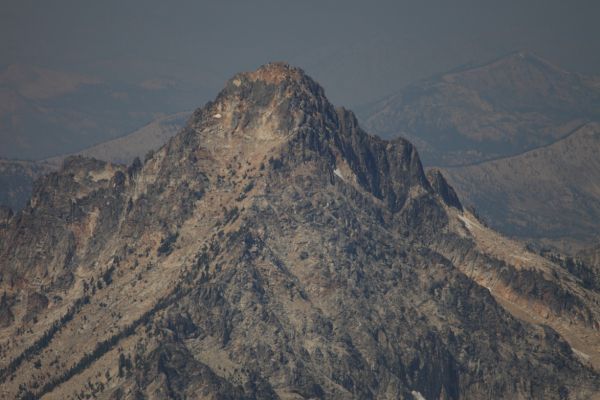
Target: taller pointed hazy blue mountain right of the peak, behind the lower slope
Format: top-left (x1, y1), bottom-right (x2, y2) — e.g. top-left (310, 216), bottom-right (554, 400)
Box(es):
top-left (361, 52), bottom-right (600, 166)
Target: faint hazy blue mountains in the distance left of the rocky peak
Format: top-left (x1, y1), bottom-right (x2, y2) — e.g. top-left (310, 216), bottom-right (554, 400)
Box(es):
top-left (0, 65), bottom-right (210, 160)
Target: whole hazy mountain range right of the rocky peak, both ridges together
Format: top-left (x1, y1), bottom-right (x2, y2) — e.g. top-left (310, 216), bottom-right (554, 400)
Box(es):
top-left (361, 52), bottom-right (600, 252)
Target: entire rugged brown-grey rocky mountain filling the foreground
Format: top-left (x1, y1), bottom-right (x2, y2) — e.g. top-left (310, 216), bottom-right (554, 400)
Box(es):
top-left (0, 63), bottom-right (600, 399)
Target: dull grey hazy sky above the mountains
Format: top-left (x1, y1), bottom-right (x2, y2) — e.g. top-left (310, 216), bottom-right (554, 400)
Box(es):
top-left (0, 0), bottom-right (600, 106)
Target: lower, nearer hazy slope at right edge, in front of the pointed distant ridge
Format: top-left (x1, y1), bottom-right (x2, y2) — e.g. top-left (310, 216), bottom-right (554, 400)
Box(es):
top-left (444, 123), bottom-right (600, 250)
